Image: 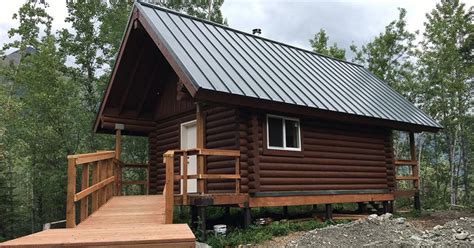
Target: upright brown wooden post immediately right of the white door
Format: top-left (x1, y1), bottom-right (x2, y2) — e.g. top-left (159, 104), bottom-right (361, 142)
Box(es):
top-left (196, 103), bottom-right (206, 194)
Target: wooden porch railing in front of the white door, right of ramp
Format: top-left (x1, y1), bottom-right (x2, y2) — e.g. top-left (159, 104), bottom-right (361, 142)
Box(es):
top-left (163, 148), bottom-right (240, 224)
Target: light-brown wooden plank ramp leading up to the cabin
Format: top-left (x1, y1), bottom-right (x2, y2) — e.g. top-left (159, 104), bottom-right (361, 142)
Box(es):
top-left (0, 195), bottom-right (195, 247)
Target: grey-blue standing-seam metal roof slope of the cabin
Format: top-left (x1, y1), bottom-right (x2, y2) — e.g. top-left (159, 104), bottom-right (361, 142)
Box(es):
top-left (136, 3), bottom-right (441, 128)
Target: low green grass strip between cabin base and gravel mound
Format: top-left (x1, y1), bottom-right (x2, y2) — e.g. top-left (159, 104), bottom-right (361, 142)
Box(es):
top-left (206, 220), bottom-right (342, 247)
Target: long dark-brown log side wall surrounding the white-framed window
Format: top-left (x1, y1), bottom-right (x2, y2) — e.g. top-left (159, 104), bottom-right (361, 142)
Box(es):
top-left (249, 114), bottom-right (393, 192)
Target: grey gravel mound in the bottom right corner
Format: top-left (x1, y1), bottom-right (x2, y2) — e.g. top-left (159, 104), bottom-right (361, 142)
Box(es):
top-left (286, 214), bottom-right (474, 247)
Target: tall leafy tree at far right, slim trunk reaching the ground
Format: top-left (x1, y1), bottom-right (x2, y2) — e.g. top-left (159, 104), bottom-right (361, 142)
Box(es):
top-left (419, 0), bottom-right (473, 205)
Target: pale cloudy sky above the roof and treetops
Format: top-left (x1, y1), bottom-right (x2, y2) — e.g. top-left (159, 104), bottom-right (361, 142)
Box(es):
top-left (0, 0), bottom-right (474, 55)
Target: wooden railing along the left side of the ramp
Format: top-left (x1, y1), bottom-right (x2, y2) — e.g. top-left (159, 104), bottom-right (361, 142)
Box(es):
top-left (66, 151), bottom-right (148, 228)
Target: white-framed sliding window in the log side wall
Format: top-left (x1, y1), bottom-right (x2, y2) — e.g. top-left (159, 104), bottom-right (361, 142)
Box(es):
top-left (267, 115), bottom-right (301, 151)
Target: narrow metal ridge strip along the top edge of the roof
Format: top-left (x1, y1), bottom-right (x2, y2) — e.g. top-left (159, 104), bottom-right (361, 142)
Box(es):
top-left (136, 0), bottom-right (365, 68)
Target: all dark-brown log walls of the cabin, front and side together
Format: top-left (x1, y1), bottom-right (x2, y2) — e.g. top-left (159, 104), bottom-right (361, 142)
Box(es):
top-left (149, 102), bottom-right (395, 196)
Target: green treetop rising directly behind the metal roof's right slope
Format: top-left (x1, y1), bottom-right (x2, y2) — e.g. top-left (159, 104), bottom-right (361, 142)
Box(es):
top-left (350, 8), bottom-right (416, 101)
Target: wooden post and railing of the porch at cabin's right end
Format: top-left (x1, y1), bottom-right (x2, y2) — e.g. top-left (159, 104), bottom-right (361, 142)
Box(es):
top-left (394, 132), bottom-right (421, 210)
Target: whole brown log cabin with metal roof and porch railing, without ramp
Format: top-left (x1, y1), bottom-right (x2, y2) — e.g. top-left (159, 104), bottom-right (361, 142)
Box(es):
top-left (94, 2), bottom-right (442, 238)
